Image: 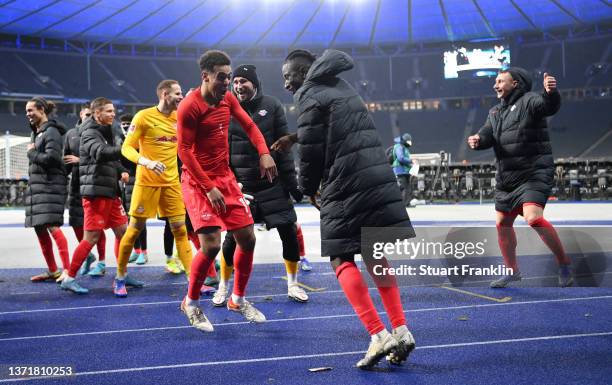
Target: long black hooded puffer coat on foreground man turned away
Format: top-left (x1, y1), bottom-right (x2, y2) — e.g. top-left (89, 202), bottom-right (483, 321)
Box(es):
top-left (294, 50), bottom-right (414, 256)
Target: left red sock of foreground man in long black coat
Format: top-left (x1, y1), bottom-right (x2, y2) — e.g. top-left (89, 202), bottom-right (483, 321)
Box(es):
top-left (336, 262), bottom-right (385, 335)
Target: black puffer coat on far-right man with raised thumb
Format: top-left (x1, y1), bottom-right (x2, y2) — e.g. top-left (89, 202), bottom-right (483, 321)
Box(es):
top-left (477, 68), bottom-right (561, 211)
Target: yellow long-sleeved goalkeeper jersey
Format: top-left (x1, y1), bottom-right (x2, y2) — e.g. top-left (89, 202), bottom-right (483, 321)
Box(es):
top-left (121, 106), bottom-right (179, 186)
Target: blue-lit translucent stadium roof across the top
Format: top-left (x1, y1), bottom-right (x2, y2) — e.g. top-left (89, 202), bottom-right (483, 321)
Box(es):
top-left (0, 0), bottom-right (612, 49)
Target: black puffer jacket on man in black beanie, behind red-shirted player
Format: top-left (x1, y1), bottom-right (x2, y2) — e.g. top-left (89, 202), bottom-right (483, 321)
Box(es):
top-left (229, 90), bottom-right (301, 228)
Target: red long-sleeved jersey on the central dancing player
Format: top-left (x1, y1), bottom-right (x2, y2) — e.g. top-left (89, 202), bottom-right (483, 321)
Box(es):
top-left (177, 88), bottom-right (270, 192)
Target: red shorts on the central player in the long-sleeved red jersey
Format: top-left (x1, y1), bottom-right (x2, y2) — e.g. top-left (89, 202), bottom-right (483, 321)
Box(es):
top-left (181, 172), bottom-right (253, 231)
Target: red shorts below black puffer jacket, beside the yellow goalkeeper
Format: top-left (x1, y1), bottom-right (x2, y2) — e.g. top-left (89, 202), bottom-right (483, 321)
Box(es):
top-left (83, 197), bottom-right (127, 231)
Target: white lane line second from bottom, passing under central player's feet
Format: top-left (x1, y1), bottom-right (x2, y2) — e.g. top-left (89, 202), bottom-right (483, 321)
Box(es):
top-left (0, 295), bottom-right (612, 342)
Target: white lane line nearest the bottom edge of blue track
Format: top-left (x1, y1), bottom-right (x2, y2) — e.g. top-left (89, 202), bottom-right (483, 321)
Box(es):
top-left (0, 331), bottom-right (612, 383)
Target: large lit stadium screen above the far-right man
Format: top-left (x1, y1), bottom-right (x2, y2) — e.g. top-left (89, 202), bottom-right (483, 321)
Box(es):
top-left (444, 44), bottom-right (510, 79)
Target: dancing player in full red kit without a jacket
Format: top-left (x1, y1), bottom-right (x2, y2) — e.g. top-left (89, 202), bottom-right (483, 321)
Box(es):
top-left (177, 50), bottom-right (277, 332)
